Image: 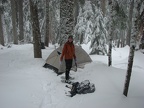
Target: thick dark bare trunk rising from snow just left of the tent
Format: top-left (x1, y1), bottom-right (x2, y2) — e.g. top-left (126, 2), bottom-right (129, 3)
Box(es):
top-left (29, 0), bottom-right (42, 58)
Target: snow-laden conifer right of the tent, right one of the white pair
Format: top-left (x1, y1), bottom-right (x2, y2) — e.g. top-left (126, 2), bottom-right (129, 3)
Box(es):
top-left (90, 1), bottom-right (107, 55)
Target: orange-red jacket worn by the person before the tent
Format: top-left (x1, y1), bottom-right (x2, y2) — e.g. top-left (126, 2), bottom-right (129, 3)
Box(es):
top-left (60, 41), bottom-right (76, 61)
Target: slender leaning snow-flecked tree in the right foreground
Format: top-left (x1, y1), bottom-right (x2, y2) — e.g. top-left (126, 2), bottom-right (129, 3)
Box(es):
top-left (123, 0), bottom-right (144, 96)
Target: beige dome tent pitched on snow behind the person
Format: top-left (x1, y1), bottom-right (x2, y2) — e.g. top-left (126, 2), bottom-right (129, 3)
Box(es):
top-left (43, 45), bottom-right (92, 74)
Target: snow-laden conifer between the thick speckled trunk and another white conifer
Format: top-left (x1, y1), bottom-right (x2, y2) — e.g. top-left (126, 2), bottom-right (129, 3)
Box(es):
top-left (74, 0), bottom-right (94, 44)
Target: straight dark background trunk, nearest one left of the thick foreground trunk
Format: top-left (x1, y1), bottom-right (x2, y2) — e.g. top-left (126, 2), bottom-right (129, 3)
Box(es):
top-left (18, 0), bottom-right (24, 42)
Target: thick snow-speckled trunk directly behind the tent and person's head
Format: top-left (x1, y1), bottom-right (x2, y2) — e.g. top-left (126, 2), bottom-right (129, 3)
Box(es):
top-left (59, 0), bottom-right (74, 45)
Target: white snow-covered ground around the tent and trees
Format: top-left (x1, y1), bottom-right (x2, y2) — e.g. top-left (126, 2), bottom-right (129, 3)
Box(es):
top-left (0, 44), bottom-right (144, 108)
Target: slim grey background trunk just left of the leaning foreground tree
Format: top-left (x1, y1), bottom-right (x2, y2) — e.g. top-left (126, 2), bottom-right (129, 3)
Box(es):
top-left (126, 0), bottom-right (134, 46)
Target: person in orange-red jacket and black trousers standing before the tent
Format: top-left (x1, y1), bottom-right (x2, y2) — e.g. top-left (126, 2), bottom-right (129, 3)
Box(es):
top-left (60, 35), bottom-right (76, 82)
